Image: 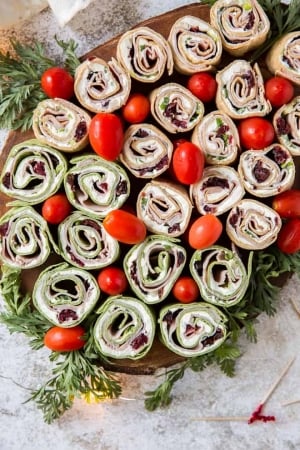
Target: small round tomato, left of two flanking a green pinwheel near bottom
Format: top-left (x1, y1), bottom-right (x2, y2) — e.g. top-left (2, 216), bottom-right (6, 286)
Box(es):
top-left (97, 266), bottom-right (128, 295)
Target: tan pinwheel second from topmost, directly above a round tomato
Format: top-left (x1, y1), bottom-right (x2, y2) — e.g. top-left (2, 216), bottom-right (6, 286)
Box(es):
top-left (168, 16), bottom-right (222, 75)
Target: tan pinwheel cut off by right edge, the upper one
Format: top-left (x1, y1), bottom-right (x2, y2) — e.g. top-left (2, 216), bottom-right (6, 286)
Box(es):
top-left (266, 30), bottom-right (300, 86)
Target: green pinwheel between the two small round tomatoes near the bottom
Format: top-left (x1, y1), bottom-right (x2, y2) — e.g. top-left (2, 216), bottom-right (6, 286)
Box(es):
top-left (124, 235), bottom-right (186, 304)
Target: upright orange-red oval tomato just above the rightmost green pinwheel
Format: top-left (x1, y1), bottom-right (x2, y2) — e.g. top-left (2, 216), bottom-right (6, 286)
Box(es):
top-left (188, 214), bottom-right (223, 250)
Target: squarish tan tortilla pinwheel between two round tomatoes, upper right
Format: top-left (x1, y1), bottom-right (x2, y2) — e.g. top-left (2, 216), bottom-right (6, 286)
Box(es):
top-left (216, 59), bottom-right (272, 119)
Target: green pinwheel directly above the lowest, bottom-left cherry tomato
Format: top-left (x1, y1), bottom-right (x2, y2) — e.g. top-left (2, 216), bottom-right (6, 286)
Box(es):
top-left (32, 263), bottom-right (100, 328)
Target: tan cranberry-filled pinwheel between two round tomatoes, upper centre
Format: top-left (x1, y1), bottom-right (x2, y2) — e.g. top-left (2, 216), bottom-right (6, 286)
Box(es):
top-left (150, 83), bottom-right (204, 133)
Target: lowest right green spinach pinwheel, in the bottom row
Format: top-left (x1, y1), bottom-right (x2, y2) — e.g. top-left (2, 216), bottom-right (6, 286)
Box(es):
top-left (159, 302), bottom-right (227, 358)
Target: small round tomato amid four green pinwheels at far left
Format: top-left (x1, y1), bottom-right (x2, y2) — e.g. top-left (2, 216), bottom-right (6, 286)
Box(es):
top-left (42, 194), bottom-right (72, 225)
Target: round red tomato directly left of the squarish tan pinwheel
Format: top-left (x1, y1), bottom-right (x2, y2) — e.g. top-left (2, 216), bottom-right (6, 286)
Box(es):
top-left (187, 72), bottom-right (217, 103)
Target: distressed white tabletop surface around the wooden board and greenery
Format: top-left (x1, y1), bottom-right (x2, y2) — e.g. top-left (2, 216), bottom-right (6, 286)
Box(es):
top-left (0, 0), bottom-right (300, 450)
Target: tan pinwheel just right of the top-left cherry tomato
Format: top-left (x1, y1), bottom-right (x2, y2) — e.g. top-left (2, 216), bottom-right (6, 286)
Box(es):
top-left (74, 57), bottom-right (131, 113)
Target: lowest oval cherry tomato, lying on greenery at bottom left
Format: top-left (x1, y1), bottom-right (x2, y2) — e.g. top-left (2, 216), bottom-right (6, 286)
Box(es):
top-left (44, 325), bottom-right (85, 352)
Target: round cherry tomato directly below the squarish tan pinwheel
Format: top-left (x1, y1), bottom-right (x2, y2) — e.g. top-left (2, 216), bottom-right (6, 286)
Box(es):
top-left (238, 117), bottom-right (275, 150)
